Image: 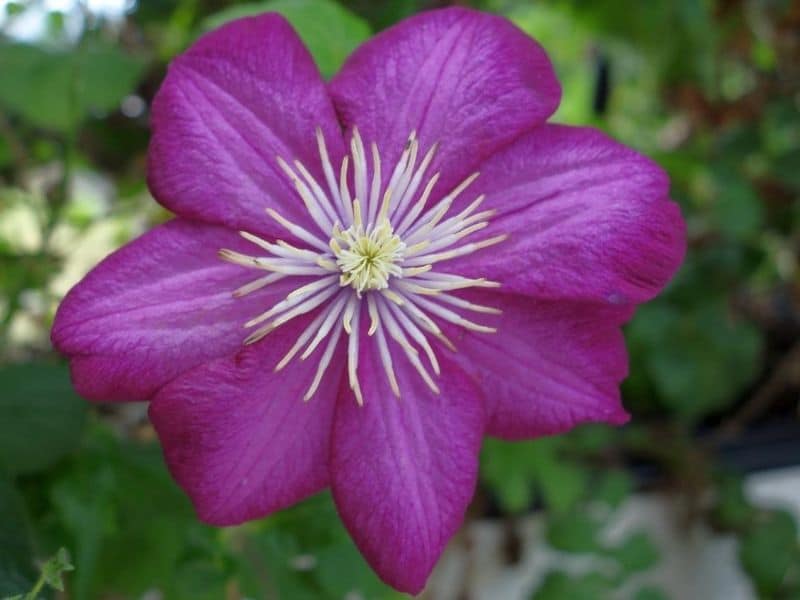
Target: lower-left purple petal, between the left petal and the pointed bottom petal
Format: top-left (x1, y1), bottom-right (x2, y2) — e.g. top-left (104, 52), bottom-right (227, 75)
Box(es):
top-left (150, 317), bottom-right (343, 525)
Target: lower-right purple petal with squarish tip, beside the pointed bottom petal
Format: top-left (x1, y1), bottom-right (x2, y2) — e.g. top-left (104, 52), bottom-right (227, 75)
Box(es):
top-left (449, 292), bottom-right (632, 439)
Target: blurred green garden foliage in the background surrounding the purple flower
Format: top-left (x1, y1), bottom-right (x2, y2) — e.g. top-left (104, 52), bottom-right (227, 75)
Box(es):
top-left (0, 0), bottom-right (800, 600)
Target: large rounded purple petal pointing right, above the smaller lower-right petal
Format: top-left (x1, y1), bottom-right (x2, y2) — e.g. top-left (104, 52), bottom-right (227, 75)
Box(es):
top-left (446, 125), bottom-right (686, 304)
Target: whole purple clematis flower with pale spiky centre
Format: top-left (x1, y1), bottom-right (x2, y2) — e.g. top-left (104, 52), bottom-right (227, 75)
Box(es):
top-left (52, 9), bottom-right (685, 593)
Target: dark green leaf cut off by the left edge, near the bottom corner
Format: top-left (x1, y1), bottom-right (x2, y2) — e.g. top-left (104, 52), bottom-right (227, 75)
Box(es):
top-left (0, 477), bottom-right (36, 598)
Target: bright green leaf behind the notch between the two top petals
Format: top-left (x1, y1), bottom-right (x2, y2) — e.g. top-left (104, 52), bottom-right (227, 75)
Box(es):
top-left (203, 0), bottom-right (371, 78)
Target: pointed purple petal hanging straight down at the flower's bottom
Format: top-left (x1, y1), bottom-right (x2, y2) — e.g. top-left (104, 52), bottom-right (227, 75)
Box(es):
top-left (330, 342), bottom-right (484, 594)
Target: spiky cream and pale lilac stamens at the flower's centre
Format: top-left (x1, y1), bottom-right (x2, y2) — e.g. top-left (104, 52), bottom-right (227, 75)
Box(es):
top-left (219, 129), bottom-right (507, 404)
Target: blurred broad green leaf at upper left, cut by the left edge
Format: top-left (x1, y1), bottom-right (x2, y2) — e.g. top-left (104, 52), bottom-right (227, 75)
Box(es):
top-left (0, 42), bottom-right (145, 132)
